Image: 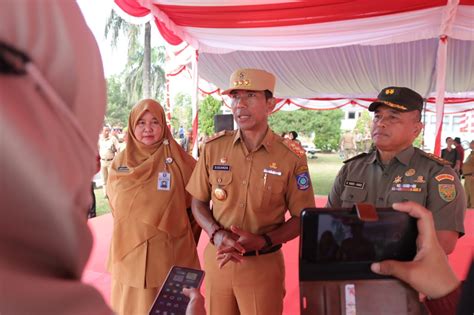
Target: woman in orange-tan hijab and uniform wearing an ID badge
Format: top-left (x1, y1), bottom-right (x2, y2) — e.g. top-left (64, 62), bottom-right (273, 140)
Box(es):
top-left (107, 99), bottom-right (200, 314)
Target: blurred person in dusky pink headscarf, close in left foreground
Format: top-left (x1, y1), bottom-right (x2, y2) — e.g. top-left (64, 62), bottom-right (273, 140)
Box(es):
top-left (0, 0), bottom-right (112, 315)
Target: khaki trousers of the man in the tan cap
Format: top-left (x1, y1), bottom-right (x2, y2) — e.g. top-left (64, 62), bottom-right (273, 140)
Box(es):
top-left (204, 244), bottom-right (285, 315)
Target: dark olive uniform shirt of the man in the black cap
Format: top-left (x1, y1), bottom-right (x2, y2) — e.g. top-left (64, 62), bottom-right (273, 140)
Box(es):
top-left (327, 146), bottom-right (466, 233)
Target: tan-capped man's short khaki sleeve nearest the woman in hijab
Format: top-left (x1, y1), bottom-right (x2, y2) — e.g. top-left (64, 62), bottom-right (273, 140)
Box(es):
top-left (186, 144), bottom-right (211, 201)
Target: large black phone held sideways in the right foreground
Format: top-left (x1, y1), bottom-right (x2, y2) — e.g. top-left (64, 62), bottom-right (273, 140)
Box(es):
top-left (300, 208), bottom-right (418, 281)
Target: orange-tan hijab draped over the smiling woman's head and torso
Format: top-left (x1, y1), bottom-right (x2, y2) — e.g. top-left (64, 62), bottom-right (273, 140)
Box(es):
top-left (107, 99), bottom-right (196, 263)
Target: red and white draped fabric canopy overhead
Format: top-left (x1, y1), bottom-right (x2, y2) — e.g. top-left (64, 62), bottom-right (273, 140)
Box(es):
top-left (115, 0), bottom-right (474, 153)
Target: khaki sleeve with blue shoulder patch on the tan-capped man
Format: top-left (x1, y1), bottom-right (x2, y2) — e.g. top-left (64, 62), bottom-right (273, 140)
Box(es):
top-left (286, 156), bottom-right (315, 217)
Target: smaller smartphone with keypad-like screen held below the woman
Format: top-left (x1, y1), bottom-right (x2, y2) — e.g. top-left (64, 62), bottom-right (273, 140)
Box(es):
top-left (149, 266), bottom-right (204, 315)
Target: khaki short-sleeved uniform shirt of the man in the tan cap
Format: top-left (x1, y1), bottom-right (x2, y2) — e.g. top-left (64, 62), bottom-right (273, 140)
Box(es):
top-left (186, 129), bottom-right (315, 234)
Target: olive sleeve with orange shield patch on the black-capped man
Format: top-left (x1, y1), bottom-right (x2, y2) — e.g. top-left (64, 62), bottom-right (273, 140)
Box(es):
top-left (426, 166), bottom-right (466, 234)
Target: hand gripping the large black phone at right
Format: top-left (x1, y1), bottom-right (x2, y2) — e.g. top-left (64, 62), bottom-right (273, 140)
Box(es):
top-left (371, 202), bottom-right (460, 299)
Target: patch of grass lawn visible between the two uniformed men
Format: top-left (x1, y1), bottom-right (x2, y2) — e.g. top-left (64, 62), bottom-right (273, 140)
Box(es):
top-left (308, 153), bottom-right (342, 196)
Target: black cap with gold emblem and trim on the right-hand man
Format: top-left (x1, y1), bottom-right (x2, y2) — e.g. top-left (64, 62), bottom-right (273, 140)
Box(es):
top-left (369, 86), bottom-right (423, 112)
